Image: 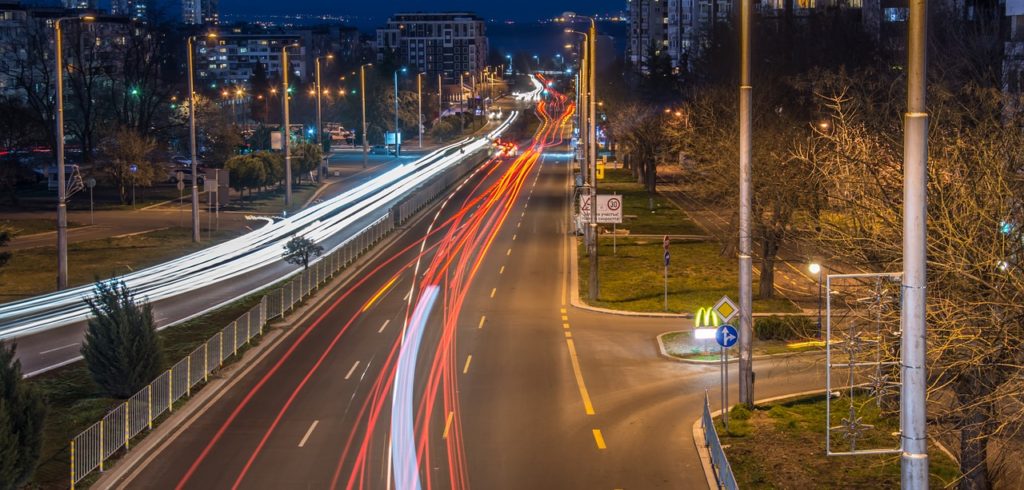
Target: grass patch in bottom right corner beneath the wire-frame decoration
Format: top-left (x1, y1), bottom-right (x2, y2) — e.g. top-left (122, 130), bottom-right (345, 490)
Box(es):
top-left (716, 395), bottom-right (959, 489)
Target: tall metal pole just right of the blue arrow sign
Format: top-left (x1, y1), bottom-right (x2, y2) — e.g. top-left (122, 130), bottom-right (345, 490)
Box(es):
top-left (739, 0), bottom-right (754, 407)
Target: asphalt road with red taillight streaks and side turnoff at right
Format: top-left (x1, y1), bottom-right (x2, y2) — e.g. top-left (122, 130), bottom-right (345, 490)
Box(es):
top-left (106, 88), bottom-right (823, 489)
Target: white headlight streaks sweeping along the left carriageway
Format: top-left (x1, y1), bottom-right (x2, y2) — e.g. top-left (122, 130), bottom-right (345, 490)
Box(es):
top-left (0, 112), bottom-right (518, 340)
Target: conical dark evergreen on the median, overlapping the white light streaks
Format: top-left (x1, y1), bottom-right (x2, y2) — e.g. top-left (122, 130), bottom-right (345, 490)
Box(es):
top-left (81, 280), bottom-right (163, 398)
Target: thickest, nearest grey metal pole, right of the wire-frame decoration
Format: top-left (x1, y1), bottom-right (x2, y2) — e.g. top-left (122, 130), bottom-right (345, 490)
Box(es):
top-left (900, 0), bottom-right (928, 482)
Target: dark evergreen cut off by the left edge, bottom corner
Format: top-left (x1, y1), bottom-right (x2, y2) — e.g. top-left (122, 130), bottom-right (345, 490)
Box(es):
top-left (0, 343), bottom-right (46, 490)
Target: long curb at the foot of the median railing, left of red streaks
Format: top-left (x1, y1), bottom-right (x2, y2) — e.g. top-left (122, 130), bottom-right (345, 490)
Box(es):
top-left (91, 219), bottom-right (408, 489)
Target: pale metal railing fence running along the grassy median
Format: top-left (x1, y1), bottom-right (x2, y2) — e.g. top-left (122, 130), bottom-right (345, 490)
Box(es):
top-left (71, 215), bottom-right (395, 490)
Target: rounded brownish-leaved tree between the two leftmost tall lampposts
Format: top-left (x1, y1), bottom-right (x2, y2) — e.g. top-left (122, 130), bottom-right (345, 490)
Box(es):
top-left (101, 127), bottom-right (159, 203)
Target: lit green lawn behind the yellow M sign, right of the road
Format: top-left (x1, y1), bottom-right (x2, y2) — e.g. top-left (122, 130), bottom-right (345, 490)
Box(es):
top-left (579, 238), bottom-right (800, 313)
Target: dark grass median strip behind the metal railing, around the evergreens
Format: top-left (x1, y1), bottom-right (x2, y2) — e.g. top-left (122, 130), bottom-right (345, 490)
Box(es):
top-left (29, 294), bottom-right (262, 489)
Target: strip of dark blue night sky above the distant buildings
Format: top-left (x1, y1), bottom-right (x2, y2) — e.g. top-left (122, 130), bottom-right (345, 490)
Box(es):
top-left (220, 0), bottom-right (627, 20)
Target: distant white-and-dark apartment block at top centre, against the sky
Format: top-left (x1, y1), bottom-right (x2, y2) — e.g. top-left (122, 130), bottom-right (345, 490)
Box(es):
top-left (377, 12), bottom-right (488, 81)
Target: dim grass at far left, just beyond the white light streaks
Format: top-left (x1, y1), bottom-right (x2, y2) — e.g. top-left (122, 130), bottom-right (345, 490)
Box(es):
top-left (0, 227), bottom-right (240, 302)
